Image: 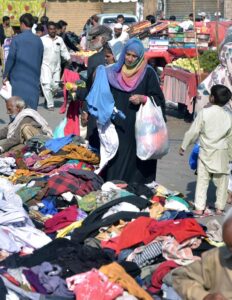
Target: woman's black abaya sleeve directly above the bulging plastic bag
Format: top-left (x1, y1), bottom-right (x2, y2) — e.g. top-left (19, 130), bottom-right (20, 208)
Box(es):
top-left (145, 67), bottom-right (166, 121)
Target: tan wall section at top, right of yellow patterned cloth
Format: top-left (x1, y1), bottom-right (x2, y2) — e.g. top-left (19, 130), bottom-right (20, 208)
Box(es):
top-left (46, 0), bottom-right (102, 34)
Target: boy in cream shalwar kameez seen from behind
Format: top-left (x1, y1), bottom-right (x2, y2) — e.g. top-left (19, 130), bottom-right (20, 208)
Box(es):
top-left (180, 85), bottom-right (232, 216)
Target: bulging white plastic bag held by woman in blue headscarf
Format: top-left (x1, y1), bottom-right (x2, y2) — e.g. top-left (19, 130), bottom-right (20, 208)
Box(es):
top-left (135, 98), bottom-right (169, 160)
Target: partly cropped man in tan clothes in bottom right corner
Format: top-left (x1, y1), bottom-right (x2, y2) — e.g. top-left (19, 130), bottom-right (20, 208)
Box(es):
top-left (172, 208), bottom-right (232, 300)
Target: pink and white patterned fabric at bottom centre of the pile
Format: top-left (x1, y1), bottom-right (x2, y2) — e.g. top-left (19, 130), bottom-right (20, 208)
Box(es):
top-left (66, 269), bottom-right (123, 300)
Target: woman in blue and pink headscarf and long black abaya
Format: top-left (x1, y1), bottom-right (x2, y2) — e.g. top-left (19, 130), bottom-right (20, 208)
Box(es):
top-left (90, 38), bottom-right (165, 184)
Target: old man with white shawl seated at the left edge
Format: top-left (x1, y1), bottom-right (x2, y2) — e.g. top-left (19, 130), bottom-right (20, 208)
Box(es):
top-left (0, 97), bottom-right (52, 153)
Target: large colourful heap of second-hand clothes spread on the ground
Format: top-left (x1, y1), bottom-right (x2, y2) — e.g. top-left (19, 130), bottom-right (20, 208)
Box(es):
top-left (0, 136), bottom-right (225, 300)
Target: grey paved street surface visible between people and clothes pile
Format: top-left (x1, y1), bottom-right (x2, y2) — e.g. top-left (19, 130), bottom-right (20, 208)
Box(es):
top-left (0, 78), bottom-right (228, 222)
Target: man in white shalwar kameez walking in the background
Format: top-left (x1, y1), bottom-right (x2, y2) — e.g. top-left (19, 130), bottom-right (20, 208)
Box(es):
top-left (40, 22), bottom-right (70, 111)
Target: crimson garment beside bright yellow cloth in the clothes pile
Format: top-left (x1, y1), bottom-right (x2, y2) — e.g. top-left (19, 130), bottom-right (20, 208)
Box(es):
top-left (44, 205), bottom-right (78, 233)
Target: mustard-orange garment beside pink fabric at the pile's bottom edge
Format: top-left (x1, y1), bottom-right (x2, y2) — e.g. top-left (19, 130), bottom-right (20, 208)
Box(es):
top-left (99, 262), bottom-right (152, 300)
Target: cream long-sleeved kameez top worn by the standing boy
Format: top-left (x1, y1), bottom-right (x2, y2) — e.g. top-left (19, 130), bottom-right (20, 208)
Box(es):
top-left (182, 105), bottom-right (232, 174)
